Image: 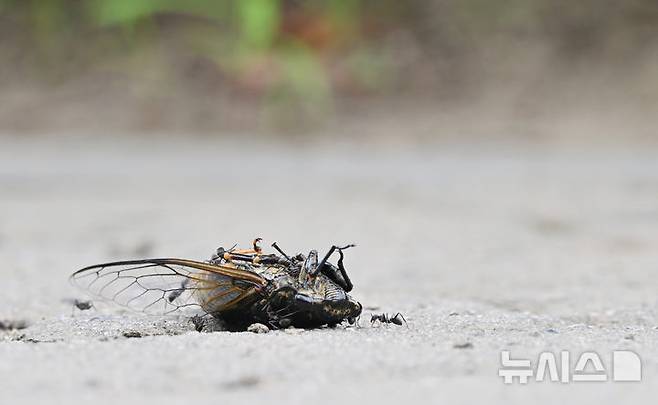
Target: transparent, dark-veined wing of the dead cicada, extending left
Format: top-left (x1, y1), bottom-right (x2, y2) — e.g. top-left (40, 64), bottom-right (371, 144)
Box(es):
top-left (71, 259), bottom-right (267, 314)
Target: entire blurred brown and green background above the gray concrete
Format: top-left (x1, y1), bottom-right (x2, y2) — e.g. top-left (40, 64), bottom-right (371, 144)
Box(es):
top-left (0, 0), bottom-right (658, 141)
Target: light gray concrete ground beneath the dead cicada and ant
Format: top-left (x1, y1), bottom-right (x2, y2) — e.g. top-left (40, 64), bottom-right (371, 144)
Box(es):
top-left (0, 137), bottom-right (658, 404)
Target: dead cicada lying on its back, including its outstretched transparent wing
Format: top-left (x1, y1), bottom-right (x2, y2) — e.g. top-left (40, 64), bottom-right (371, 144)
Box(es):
top-left (71, 238), bottom-right (362, 330)
